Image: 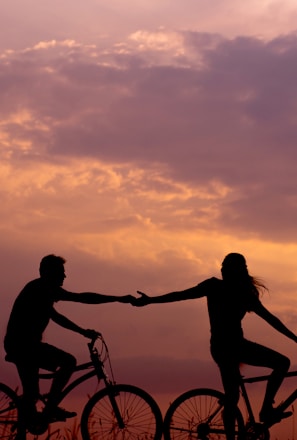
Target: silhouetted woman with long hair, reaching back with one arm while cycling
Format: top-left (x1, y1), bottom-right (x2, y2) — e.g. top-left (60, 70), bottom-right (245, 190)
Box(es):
top-left (135, 253), bottom-right (297, 440)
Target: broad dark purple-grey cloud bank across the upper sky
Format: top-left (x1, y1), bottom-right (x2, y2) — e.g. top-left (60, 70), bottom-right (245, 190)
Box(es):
top-left (0, 33), bottom-right (297, 172)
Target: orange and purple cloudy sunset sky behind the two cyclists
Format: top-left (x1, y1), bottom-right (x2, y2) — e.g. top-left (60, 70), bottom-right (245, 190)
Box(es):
top-left (0, 0), bottom-right (297, 436)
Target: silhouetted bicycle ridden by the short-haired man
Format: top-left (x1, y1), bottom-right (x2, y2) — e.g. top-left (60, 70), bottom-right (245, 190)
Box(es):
top-left (0, 334), bottom-right (163, 440)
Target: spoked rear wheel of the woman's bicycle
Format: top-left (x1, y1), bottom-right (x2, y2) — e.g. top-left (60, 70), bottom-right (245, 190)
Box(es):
top-left (164, 388), bottom-right (244, 440)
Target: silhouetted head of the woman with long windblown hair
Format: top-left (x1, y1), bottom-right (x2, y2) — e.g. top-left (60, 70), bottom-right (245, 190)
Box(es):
top-left (221, 252), bottom-right (268, 298)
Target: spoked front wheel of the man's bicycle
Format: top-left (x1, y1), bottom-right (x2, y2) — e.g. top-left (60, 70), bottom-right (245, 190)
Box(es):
top-left (81, 385), bottom-right (163, 440)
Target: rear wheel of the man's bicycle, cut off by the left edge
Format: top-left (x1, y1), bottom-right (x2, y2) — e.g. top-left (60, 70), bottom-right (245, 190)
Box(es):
top-left (0, 383), bottom-right (18, 440)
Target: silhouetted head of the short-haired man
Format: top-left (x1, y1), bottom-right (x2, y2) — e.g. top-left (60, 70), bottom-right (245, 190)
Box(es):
top-left (39, 254), bottom-right (66, 286)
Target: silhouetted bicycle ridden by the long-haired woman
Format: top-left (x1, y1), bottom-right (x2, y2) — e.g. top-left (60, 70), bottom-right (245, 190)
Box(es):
top-left (164, 371), bottom-right (297, 440)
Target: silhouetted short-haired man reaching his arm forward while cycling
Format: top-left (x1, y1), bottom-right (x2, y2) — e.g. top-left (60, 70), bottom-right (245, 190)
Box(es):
top-left (4, 254), bottom-right (134, 423)
